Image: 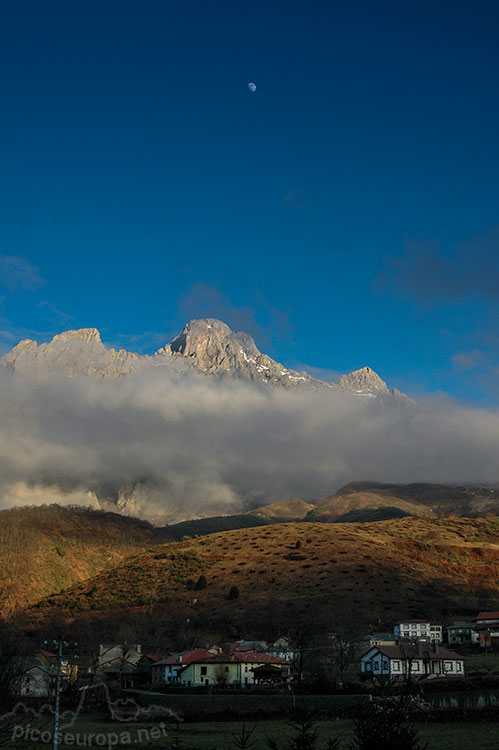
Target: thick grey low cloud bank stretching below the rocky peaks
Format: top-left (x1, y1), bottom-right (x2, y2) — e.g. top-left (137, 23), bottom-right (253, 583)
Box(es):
top-left (0, 369), bottom-right (499, 522)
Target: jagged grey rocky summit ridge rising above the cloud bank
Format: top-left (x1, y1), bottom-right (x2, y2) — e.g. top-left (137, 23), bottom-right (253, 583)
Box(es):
top-left (0, 318), bottom-right (394, 398)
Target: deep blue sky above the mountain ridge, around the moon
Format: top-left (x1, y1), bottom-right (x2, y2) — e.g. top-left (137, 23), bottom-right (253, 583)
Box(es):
top-left (0, 0), bottom-right (499, 406)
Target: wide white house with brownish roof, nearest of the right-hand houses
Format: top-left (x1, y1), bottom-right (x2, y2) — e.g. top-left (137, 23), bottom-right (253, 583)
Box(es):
top-left (360, 643), bottom-right (464, 679)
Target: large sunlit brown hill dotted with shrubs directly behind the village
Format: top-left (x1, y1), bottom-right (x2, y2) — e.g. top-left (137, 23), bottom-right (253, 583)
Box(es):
top-left (31, 517), bottom-right (499, 623)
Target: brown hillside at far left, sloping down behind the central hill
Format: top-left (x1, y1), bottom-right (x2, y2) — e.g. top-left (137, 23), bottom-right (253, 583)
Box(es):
top-left (0, 505), bottom-right (171, 616)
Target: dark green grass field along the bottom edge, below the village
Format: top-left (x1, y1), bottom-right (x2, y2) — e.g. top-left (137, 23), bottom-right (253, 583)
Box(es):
top-left (0, 715), bottom-right (499, 750)
